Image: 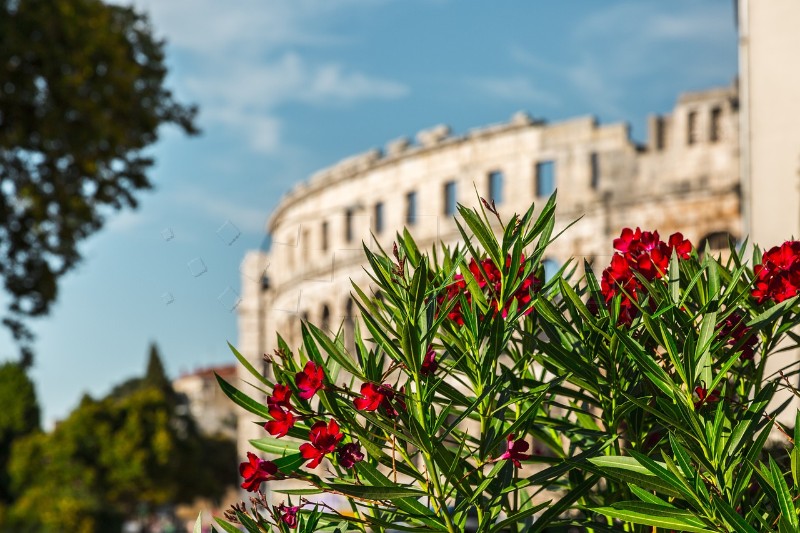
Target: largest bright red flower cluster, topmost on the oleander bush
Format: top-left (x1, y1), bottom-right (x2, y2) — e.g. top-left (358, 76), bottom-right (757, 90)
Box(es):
top-left (600, 228), bottom-right (692, 324)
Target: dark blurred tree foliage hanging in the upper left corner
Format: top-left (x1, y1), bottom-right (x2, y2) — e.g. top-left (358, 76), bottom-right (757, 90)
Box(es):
top-left (0, 0), bottom-right (196, 355)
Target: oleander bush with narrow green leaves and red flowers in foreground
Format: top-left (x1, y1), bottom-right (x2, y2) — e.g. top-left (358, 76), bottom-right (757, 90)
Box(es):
top-left (211, 197), bottom-right (800, 533)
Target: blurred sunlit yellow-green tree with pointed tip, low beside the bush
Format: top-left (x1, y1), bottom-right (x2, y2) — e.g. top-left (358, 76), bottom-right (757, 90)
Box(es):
top-left (6, 350), bottom-right (236, 533)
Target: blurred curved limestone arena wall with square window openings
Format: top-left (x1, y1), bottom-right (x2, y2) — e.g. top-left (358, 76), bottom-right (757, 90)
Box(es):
top-left (238, 86), bottom-right (743, 453)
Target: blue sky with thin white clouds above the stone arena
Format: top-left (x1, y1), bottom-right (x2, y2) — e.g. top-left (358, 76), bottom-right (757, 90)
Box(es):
top-left (3, 0), bottom-right (736, 424)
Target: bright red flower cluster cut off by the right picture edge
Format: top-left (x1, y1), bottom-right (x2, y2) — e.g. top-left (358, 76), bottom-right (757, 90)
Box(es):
top-left (752, 241), bottom-right (800, 303)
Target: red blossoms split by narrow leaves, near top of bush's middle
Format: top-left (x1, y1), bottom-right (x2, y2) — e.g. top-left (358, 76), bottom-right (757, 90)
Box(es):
top-left (438, 255), bottom-right (541, 326)
